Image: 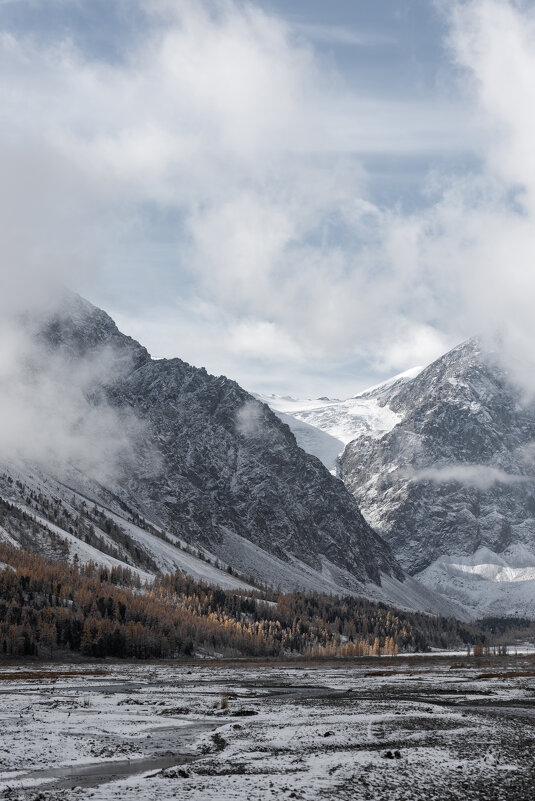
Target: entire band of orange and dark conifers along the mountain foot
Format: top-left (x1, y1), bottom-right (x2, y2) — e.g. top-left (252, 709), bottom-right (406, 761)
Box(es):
top-left (0, 543), bottom-right (528, 659)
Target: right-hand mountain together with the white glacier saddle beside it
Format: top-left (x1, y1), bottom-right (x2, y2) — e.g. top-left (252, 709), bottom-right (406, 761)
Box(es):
top-left (269, 339), bottom-right (535, 617)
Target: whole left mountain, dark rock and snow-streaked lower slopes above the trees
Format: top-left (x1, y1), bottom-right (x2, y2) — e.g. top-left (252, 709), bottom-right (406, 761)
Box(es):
top-left (0, 295), bottom-right (453, 612)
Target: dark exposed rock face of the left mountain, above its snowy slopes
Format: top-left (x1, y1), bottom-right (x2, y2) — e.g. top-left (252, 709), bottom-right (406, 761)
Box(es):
top-left (25, 298), bottom-right (402, 586)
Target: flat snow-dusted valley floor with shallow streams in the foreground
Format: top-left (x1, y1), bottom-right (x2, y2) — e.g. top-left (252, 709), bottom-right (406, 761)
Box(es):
top-left (0, 655), bottom-right (535, 801)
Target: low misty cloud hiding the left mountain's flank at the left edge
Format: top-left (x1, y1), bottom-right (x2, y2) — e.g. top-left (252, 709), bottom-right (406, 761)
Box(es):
top-left (0, 309), bottom-right (149, 482)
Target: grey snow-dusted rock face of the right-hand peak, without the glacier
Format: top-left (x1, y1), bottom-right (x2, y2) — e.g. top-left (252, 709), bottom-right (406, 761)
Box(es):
top-left (342, 340), bottom-right (535, 576)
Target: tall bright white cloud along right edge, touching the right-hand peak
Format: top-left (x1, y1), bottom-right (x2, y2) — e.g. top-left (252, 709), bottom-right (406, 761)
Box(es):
top-left (414, 0), bottom-right (535, 395)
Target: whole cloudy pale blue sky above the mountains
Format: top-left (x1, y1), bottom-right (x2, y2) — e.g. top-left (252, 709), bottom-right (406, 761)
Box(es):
top-left (0, 0), bottom-right (535, 396)
